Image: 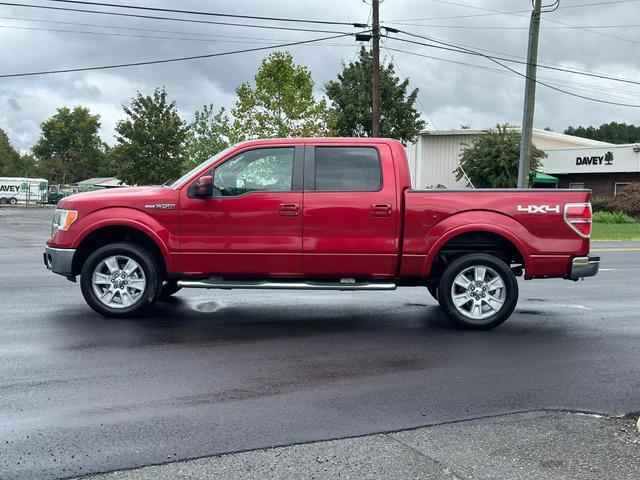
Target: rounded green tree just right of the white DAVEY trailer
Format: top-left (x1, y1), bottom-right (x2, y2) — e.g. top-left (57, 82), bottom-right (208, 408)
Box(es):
top-left (33, 107), bottom-right (105, 183)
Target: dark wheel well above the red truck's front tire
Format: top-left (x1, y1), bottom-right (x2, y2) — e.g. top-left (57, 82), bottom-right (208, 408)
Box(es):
top-left (72, 226), bottom-right (167, 277)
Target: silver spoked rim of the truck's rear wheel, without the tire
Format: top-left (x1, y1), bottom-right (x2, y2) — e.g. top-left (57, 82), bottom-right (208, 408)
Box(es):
top-left (451, 265), bottom-right (507, 323)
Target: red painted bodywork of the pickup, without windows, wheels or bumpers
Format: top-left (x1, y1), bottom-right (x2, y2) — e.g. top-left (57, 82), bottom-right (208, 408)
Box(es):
top-left (47, 138), bottom-right (590, 279)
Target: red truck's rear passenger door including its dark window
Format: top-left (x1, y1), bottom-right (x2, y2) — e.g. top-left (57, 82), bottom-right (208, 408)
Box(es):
top-left (303, 143), bottom-right (400, 277)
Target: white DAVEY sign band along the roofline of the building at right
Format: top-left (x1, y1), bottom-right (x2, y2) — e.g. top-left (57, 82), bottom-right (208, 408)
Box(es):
top-left (543, 145), bottom-right (640, 175)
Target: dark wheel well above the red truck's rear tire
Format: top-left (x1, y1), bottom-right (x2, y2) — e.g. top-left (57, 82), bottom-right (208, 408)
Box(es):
top-left (429, 231), bottom-right (524, 279)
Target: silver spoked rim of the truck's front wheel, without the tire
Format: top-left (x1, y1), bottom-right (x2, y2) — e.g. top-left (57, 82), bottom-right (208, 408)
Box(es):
top-left (91, 255), bottom-right (147, 309)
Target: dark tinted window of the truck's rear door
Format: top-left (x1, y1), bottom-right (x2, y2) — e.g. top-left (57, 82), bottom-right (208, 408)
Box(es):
top-left (315, 147), bottom-right (382, 192)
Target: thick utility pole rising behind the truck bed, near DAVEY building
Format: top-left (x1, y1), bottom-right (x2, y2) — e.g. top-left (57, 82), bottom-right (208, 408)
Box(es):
top-left (518, 0), bottom-right (542, 188)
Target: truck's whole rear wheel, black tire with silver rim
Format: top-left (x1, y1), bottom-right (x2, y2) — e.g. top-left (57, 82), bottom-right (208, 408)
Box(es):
top-left (438, 253), bottom-right (518, 330)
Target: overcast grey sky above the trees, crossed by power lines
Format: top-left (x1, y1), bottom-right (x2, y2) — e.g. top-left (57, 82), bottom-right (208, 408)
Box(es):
top-left (0, 0), bottom-right (640, 150)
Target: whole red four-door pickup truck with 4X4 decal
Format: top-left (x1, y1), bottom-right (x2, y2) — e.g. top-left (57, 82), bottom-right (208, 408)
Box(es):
top-left (44, 138), bottom-right (599, 329)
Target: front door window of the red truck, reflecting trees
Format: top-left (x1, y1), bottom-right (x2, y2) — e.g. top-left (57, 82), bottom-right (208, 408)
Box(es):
top-left (213, 147), bottom-right (294, 197)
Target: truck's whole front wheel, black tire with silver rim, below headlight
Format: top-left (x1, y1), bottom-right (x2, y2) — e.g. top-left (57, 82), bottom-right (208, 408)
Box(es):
top-left (80, 242), bottom-right (162, 318)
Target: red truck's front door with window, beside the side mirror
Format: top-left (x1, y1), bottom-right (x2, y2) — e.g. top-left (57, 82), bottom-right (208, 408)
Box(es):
top-left (180, 147), bottom-right (303, 276)
